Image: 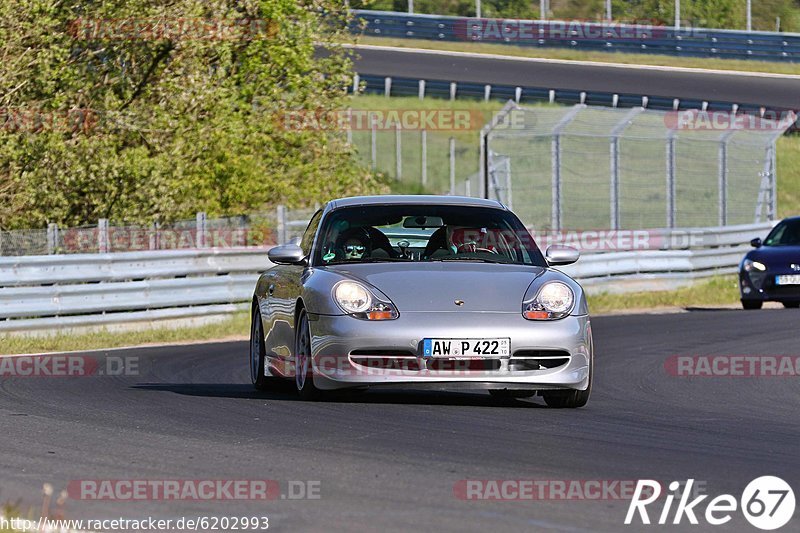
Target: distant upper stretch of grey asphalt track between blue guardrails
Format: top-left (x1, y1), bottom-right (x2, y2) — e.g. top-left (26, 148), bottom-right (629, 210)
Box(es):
top-left (355, 48), bottom-right (800, 109)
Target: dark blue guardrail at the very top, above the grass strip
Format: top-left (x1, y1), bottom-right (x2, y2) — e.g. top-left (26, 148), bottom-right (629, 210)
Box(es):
top-left (351, 10), bottom-right (800, 62)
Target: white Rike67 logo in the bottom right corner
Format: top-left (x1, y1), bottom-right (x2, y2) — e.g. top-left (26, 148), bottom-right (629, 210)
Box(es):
top-left (625, 476), bottom-right (795, 531)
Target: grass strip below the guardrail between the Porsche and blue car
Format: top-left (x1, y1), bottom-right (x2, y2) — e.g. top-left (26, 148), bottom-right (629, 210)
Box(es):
top-left (587, 275), bottom-right (739, 314)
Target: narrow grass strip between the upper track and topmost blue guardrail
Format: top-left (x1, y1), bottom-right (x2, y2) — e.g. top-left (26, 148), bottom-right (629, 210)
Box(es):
top-left (359, 36), bottom-right (800, 74)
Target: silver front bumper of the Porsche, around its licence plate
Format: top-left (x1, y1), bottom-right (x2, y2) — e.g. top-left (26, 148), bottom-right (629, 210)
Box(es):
top-left (309, 312), bottom-right (593, 390)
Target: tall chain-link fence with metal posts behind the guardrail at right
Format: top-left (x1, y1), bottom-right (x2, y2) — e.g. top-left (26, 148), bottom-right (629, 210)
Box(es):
top-left (482, 102), bottom-right (796, 230)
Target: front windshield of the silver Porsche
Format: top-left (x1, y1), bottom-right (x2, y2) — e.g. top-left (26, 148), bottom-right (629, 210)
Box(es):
top-left (314, 205), bottom-right (546, 266)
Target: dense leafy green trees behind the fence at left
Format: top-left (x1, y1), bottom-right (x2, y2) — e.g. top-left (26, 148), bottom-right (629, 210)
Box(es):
top-left (0, 0), bottom-right (381, 228)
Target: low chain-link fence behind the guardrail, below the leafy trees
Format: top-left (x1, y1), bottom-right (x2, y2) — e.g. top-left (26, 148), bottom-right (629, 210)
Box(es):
top-left (0, 206), bottom-right (318, 256)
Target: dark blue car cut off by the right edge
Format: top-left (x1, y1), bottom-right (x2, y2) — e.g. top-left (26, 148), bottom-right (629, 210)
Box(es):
top-left (739, 217), bottom-right (800, 309)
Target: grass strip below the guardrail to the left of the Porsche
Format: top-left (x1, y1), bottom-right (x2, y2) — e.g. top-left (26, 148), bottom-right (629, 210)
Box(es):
top-left (0, 312), bottom-right (250, 355)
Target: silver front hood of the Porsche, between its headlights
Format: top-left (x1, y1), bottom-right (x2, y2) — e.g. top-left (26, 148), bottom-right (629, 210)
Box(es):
top-left (328, 262), bottom-right (545, 313)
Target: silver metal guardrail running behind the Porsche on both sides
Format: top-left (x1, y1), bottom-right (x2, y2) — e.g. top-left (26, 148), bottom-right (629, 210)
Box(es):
top-left (0, 223), bottom-right (772, 333)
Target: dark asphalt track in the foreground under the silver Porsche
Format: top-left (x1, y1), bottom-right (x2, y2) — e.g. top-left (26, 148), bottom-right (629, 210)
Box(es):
top-left (0, 309), bottom-right (800, 532)
